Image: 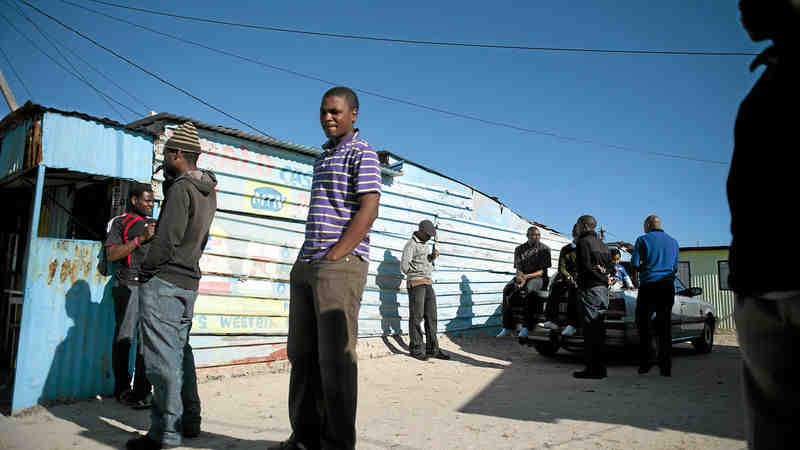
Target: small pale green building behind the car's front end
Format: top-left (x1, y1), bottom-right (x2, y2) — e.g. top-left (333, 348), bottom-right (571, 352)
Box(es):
top-left (678, 245), bottom-right (736, 329)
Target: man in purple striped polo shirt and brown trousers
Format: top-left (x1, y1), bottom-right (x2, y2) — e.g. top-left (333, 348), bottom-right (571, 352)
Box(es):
top-left (274, 87), bottom-right (381, 449)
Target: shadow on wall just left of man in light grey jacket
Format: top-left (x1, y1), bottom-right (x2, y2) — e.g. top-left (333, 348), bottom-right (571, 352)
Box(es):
top-left (375, 249), bottom-right (408, 353)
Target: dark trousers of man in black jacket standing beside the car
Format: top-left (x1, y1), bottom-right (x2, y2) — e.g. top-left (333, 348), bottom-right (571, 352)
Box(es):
top-left (578, 286), bottom-right (608, 372)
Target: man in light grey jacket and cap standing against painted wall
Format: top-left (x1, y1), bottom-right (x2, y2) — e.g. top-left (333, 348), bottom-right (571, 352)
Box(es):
top-left (400, 220), bottom-right (450, 361)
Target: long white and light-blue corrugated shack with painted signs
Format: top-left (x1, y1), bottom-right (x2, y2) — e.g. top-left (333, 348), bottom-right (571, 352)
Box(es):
top-left (129, 113), bottom-right (569, 367)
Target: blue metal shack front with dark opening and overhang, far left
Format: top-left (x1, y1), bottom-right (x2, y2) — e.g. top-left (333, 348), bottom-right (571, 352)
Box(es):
top-left (0, 103), bottom-right (153, 413)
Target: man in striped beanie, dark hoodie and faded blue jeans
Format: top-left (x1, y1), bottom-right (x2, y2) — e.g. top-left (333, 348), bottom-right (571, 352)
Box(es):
top-left (126, 122), bottom-right (217, 449)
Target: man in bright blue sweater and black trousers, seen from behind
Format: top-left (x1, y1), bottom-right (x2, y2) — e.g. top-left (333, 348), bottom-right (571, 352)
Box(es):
top-left (631, 216), bottom-right (679, 377)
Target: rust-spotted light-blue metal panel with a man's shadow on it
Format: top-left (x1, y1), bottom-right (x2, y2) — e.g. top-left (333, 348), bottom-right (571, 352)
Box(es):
top-left (12, 238), bottom-right (114, 413)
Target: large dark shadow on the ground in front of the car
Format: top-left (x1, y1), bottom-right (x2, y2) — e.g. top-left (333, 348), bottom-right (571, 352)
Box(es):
top-left (454, 337), bottom-right (744, 439)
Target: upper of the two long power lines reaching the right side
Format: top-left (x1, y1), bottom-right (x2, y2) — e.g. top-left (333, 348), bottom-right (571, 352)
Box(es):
top-left (76, 0), bottom-right (758, 56)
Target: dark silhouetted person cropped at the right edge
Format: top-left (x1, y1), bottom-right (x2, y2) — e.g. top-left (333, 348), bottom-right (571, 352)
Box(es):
top-left (732, 0), bottom-right (800, 449)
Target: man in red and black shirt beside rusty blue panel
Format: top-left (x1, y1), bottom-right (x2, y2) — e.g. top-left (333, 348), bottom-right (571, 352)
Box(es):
top-left (105, 183), bottom-right (155, 409)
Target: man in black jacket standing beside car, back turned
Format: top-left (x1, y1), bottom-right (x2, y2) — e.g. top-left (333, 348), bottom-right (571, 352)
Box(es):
top-left (573, 216), bottom-right (613, 379)
